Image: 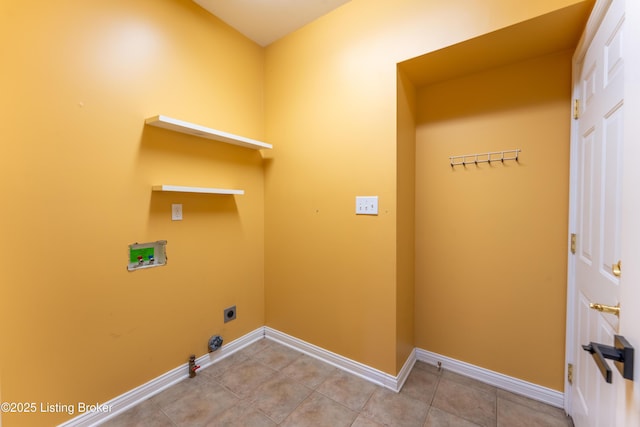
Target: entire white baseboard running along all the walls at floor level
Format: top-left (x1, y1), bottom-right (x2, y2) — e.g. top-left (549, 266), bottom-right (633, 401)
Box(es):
top-left (59, 326), bottom-right (564, 427)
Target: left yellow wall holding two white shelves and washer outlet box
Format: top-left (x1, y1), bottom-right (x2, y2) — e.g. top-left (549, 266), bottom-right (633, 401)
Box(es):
top-left (0, 0), bottom-right (264, 426)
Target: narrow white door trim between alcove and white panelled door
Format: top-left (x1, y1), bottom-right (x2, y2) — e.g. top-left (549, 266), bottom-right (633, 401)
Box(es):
top-left (564, 0), bottom-right (613, 415)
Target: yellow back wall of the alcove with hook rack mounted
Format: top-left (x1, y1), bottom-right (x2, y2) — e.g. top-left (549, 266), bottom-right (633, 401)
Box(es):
top-left (416, 51), bottom-right (571, 390)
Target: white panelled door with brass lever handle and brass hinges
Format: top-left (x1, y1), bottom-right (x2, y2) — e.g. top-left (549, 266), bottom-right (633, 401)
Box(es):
top-left (571, 0), bottom-right (624, 427)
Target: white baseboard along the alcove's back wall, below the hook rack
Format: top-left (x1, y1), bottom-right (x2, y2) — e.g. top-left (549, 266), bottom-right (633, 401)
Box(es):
top-left (415, 349), bottom-right (564, 408)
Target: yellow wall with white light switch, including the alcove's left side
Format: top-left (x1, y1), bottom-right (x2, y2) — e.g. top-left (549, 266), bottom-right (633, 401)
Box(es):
top-left (265, 0), bottom-right (585, 383)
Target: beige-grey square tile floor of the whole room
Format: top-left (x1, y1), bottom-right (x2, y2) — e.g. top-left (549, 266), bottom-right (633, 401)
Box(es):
top-left (103, 339), bottom-right (573, 427)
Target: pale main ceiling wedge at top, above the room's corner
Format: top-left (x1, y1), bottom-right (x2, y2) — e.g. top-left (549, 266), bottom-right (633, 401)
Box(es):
top-left (193, 0), bottom-right (350, 46)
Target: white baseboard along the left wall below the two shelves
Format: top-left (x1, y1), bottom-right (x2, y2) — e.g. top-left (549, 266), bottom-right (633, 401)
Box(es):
top-left (59, 328), bottom-right (264, 427)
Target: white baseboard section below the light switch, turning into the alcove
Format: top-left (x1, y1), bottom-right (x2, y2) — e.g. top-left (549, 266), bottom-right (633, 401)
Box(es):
top-left (264, 326), bottom-right (416, 392)
